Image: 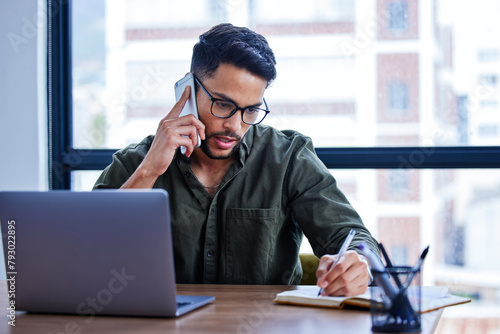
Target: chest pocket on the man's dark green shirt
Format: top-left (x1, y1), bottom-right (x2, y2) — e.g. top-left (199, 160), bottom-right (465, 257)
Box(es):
top-left (225, 208), bottom-right (279, 284)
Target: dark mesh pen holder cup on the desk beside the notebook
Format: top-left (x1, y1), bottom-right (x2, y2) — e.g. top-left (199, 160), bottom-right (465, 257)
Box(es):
top-left (370, 266), bottom-right (421, 333)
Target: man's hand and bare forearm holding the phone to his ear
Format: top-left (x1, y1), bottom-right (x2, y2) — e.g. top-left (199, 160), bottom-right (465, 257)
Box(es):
top-left (121, 86), bottom-right (205, 188)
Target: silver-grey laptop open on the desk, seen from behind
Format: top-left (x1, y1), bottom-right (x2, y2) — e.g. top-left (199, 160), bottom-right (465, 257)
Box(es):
top-left (0, 190), bottom-right (215, 317)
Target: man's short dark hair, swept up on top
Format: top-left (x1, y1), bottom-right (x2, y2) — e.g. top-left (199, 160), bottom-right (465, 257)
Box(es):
top-left (191, 23), bottom-right (276, 85)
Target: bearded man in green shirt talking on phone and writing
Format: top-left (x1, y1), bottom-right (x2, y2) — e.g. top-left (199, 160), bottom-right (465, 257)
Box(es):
top-left (95, 24), bottom-right (376, 295)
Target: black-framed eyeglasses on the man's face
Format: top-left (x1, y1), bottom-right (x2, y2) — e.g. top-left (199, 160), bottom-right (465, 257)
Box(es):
top-left (194, 77), bottom-right (270, 125)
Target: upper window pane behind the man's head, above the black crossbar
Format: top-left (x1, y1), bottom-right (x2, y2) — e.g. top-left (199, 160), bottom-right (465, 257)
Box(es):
top-left (72, 0), bottom-right (500, 148)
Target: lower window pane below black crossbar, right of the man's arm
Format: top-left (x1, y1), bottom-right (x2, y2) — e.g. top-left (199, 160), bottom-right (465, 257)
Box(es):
top-left (301, 169), bottom-right (500, 333)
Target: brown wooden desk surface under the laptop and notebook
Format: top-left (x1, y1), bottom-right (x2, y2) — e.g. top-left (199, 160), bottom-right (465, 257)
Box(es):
top-left (0, 281), bottom-right (442, 334)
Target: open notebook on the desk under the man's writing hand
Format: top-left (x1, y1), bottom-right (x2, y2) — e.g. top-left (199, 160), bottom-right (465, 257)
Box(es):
top-left (274, 285), bottom-right (471, 313)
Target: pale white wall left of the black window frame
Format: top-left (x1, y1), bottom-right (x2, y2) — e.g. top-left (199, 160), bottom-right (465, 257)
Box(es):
top-left (0, 0), bottom-right (48, 278)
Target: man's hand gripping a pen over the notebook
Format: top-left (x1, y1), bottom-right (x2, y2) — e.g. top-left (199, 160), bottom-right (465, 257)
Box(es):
top-left (316, 251), bottom-right (370, 296)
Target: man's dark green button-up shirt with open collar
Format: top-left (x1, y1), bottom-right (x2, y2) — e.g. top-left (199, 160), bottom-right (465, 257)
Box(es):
top-left (95, 125), bottom-right (377, 284)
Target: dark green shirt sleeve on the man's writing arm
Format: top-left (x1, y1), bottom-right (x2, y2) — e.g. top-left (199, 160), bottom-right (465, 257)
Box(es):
top-left (287, 138), bottom-right (379, 257)
